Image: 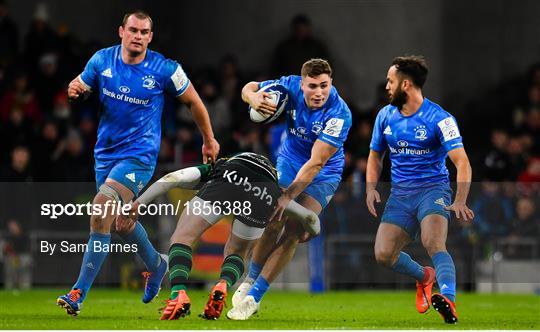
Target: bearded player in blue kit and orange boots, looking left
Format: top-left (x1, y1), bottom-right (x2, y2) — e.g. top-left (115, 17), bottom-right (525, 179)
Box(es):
top-left (366, 56), bottom-right (474, 324)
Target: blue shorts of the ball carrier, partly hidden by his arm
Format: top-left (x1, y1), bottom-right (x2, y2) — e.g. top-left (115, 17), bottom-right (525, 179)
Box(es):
top-left (276, 158), bottom-right (339, 209)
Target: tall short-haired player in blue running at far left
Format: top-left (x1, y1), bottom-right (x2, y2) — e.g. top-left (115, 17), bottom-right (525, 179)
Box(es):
top-left (57, 11), bottom-right (219, 316)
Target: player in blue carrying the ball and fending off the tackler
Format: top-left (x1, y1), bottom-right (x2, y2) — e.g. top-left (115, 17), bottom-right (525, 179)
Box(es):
top-left (227, 59), bottom-right (351, 320)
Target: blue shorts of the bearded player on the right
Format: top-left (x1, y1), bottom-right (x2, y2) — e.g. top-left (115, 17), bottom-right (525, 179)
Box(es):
top-left (381, 185), bottom-right (452, 239)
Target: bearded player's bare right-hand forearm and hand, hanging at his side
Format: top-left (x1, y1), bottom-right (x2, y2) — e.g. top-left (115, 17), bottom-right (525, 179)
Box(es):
top-left (445, 148), bottom-right (474, 221)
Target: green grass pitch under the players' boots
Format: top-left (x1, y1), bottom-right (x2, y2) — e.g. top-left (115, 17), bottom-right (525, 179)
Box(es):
top-left (0, 289), bottom-right (540, 330)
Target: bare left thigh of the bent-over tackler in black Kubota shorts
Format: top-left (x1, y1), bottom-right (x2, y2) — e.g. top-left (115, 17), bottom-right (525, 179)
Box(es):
top-left (171, 196), bottom-right (224, 246)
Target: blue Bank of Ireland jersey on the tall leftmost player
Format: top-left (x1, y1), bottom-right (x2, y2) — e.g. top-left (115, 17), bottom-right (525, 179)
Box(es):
top-left (81, 45), bottom-right (190, 166)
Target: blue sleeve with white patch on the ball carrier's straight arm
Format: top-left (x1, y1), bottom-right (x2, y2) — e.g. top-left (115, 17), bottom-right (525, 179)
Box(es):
top-left (317, 105), bottom-right (352, 148)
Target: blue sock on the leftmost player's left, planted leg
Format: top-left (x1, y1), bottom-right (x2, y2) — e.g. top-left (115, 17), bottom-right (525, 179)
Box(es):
top-left (73, 233), bottom-right (111, 301)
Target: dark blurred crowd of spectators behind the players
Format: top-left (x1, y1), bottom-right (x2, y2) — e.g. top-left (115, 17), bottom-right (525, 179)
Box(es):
top-left (0, 0), bottom-right (540, 286)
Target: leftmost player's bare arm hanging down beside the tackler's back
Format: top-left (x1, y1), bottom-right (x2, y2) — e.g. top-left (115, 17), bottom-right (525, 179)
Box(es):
top-left (178, 83), bottom-right (219, 164)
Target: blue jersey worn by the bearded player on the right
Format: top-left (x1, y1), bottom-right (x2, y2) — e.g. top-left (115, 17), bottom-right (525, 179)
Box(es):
top-left (370, 98), bottom-right (463, 190)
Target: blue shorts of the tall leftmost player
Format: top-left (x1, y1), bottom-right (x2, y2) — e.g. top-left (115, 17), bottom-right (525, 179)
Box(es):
top-left (94, 158), bottom-right (155, 197)
